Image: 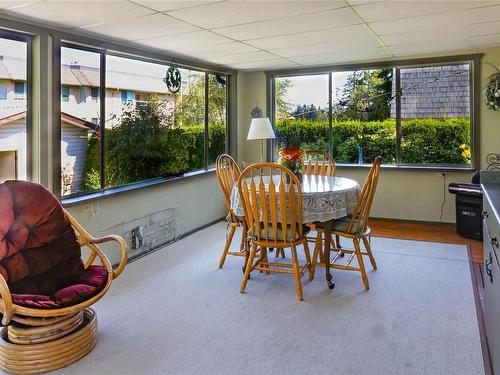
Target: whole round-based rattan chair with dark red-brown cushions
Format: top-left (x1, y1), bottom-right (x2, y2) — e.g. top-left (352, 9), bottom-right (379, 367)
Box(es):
top-left (0, 181), bottom-right (127, 374)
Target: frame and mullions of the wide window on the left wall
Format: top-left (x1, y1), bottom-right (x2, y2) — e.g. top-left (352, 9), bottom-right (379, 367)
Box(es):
top-left (58, 38), bottom-right (231, 203)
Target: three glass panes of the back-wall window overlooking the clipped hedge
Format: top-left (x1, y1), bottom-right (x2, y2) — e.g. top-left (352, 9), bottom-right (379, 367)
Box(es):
top-left (271, 57), bottom-right (474, 168)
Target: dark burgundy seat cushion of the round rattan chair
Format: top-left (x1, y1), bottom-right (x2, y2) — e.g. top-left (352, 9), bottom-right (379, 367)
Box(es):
top-left (12, 266), bottom-right (108, 309)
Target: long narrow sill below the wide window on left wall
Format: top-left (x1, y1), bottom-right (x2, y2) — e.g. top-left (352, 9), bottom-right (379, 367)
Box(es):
top-left (61, 168), bottom-right (215, 207)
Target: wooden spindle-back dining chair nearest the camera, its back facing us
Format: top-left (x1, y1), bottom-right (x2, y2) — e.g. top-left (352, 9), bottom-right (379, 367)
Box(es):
top-left (238, 163), bottom-right (311, 301)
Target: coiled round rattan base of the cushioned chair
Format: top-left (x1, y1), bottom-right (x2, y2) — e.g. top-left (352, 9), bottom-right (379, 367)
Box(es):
top-left (0, 308), bottom-right (97, 374)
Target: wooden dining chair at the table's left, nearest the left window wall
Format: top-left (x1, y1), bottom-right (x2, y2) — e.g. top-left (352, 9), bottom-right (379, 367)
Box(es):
top-left (215, 154), bottom-right (247, 268)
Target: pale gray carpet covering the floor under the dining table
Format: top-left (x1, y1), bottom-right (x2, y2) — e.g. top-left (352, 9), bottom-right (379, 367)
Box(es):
top-left (47, 223), bottom-right (484, 375)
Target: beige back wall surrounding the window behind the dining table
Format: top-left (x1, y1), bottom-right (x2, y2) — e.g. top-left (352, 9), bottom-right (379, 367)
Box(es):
top-left (238, 48), bottom-right (500, 222)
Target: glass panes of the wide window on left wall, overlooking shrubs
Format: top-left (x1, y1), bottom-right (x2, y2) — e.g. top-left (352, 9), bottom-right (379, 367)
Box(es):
top-left (61, 46), bottom-right (228, 195)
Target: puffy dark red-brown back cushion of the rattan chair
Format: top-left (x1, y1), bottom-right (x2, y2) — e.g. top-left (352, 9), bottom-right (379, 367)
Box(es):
top-left (0, 181), bottom-right (108, 307)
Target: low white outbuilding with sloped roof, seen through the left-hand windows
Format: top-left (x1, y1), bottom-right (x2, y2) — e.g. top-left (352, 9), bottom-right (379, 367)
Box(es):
top-left (0, 111), bottom-right (96, 192)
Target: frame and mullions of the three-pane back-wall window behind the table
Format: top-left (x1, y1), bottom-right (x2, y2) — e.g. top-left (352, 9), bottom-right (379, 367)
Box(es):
top-left (265, 54), bottom-right (483, 171)
